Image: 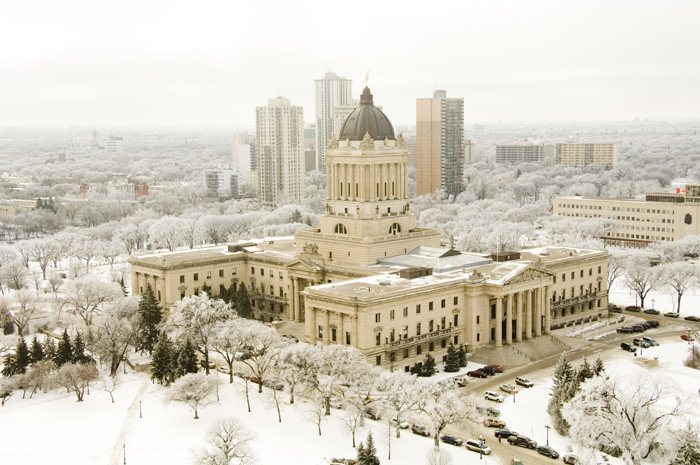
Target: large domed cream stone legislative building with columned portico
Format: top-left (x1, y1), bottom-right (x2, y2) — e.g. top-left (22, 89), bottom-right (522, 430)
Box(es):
top-left (130, 88), bottom-right (608, 370)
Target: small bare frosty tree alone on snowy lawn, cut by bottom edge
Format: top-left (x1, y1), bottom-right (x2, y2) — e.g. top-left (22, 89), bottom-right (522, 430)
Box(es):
top-left (197, 418), bottom-right (255, 465)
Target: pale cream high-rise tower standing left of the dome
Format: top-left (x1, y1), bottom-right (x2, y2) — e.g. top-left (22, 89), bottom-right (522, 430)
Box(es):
top-left (255, 97), bottom-right (304, 207)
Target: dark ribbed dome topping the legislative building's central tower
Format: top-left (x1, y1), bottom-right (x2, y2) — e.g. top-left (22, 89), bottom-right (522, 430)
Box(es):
top-left (338, 87), bottom-right (396, 140)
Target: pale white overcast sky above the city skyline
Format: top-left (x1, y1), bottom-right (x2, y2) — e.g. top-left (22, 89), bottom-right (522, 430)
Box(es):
top-left (0, 0), bottom-right (700, 127)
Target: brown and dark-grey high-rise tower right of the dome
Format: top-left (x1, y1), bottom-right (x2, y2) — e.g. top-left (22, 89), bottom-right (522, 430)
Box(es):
top-left (416, 90), bottom-right (464, 196)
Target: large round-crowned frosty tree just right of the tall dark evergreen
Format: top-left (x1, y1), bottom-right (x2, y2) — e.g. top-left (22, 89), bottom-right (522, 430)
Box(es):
top-left (166, 294), bottom-right (236, 374)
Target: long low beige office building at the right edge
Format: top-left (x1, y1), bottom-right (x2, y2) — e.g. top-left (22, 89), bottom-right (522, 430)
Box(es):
top-left (552, 184), bottom-right (700, 247)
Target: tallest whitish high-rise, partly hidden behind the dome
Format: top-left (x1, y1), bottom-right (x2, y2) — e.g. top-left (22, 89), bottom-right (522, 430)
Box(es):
top-left (314, 72), bottom-right (352, 171)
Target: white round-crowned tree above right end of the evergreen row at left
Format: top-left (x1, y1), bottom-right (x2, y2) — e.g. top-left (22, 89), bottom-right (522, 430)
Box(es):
top-left (63, 276), bottom-right (123, 327)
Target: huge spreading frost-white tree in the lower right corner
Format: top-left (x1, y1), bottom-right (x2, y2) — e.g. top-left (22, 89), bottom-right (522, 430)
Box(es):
top-left (562, 375), bottom-right (681, 465)
